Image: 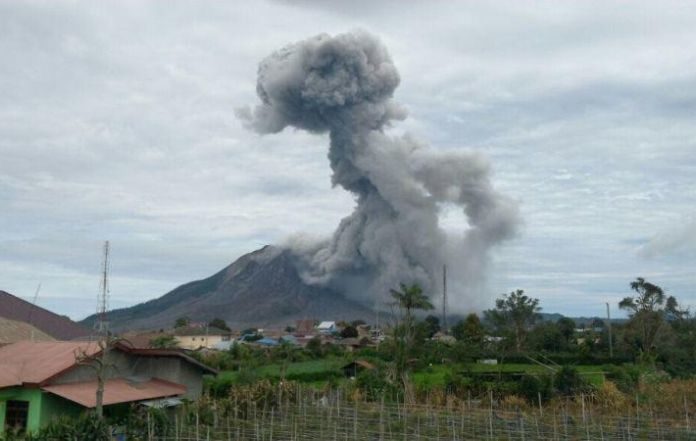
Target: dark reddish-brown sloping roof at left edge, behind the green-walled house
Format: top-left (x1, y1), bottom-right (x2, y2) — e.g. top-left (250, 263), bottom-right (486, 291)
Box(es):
top-left (0, 291), bottom-right (91, 340)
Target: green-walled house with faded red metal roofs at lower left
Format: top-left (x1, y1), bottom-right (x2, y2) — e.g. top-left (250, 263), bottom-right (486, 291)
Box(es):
top-left (0, 341), bottom-right (216, 434)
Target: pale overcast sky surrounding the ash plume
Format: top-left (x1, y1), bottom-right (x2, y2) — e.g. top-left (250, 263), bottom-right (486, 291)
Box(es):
top-left (0, 0), bottom-right (696, 319)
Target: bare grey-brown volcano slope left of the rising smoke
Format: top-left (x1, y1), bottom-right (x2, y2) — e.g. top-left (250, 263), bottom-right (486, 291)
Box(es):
top-left (83, 246), bottom-right (372, 331)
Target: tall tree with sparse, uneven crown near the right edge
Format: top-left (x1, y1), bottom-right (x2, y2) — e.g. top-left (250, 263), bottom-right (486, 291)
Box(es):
top-left (619, 277), bottom-right (688, 363)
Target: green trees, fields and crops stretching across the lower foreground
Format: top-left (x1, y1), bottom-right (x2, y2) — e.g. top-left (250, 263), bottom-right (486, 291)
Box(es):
top-left (13, 278), bottom-right (696, 439)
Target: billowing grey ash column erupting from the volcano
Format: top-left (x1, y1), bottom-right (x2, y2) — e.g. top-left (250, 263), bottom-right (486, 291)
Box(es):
top-left (237, 32), bottom-right (518, 311)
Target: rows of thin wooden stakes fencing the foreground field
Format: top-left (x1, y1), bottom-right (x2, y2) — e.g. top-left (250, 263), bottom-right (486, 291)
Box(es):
top-left (147, 388), bottom-right (696, 441)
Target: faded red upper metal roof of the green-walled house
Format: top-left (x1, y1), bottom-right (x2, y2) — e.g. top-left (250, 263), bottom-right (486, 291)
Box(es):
top-left (0, 341), bottom-right (100, 388)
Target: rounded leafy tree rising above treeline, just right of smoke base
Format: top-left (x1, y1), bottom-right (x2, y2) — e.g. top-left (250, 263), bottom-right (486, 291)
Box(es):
top-left (484, 289), bottom-right (541, 352)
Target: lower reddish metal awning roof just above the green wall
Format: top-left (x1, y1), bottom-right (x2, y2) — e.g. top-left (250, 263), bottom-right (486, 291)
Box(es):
top-left (42, 378), bottom-right (186, 407)
